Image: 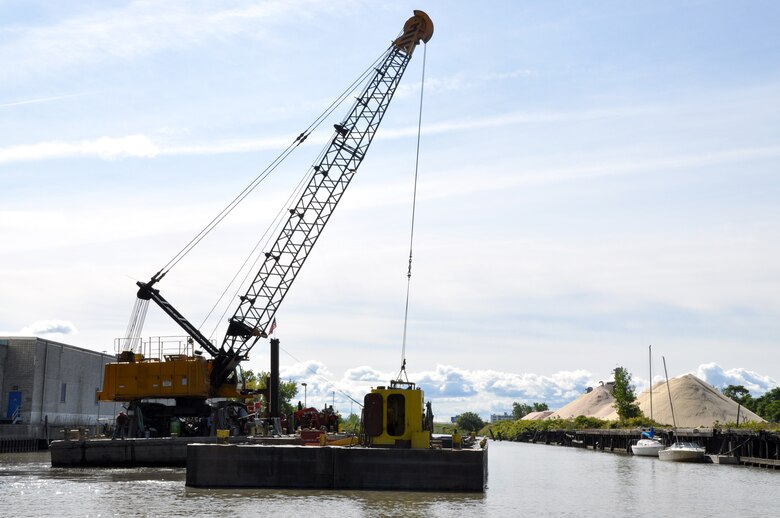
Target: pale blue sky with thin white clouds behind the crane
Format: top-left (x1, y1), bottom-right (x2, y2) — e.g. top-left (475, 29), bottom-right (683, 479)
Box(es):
top-left (0, 0), bottom-right (780, 418)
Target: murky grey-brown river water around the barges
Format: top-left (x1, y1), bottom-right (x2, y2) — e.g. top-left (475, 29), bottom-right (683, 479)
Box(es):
top-left (0, 442), bottom-right (780, 518)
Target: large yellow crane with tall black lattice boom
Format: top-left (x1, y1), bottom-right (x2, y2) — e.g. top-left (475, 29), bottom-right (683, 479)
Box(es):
top-left (99, 10), bottom-right (433, 436)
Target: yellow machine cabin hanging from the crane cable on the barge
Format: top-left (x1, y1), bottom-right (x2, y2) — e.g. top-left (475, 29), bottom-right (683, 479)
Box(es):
top-left (363, 380), bottom-right (433, 449)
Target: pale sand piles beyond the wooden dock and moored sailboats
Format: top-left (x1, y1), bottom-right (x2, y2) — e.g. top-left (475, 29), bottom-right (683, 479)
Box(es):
top-left (600, 374), bottom-right (764, 428)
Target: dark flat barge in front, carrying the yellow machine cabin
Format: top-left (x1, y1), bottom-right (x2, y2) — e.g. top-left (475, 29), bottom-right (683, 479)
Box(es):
top-left (187, 379), bottom-right (488, 492)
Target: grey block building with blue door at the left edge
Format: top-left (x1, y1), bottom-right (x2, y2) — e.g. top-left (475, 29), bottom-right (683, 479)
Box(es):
top-left (0, 337), bottom-right (118, 439)
